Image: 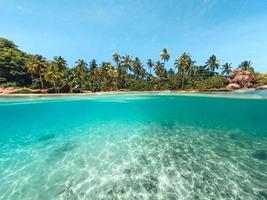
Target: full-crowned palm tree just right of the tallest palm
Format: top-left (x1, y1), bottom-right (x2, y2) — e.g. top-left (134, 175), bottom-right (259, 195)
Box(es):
top-left (174, 52), bottom-right (194, 89)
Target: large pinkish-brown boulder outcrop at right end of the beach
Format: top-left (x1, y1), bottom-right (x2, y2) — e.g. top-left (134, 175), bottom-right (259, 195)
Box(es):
top-left (227, 69), bottom-right (255, 89)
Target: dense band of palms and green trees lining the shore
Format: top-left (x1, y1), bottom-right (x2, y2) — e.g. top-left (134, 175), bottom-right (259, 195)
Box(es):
top-left (0, 38), bottom-right (267, 93)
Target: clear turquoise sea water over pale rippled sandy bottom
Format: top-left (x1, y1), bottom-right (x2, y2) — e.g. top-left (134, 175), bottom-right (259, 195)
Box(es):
top-left (0, 91), bottom-right (267, 200)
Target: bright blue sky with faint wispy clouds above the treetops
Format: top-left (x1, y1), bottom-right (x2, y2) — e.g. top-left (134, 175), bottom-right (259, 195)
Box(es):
top-left (0, 0), bottom-right (267, 72)
